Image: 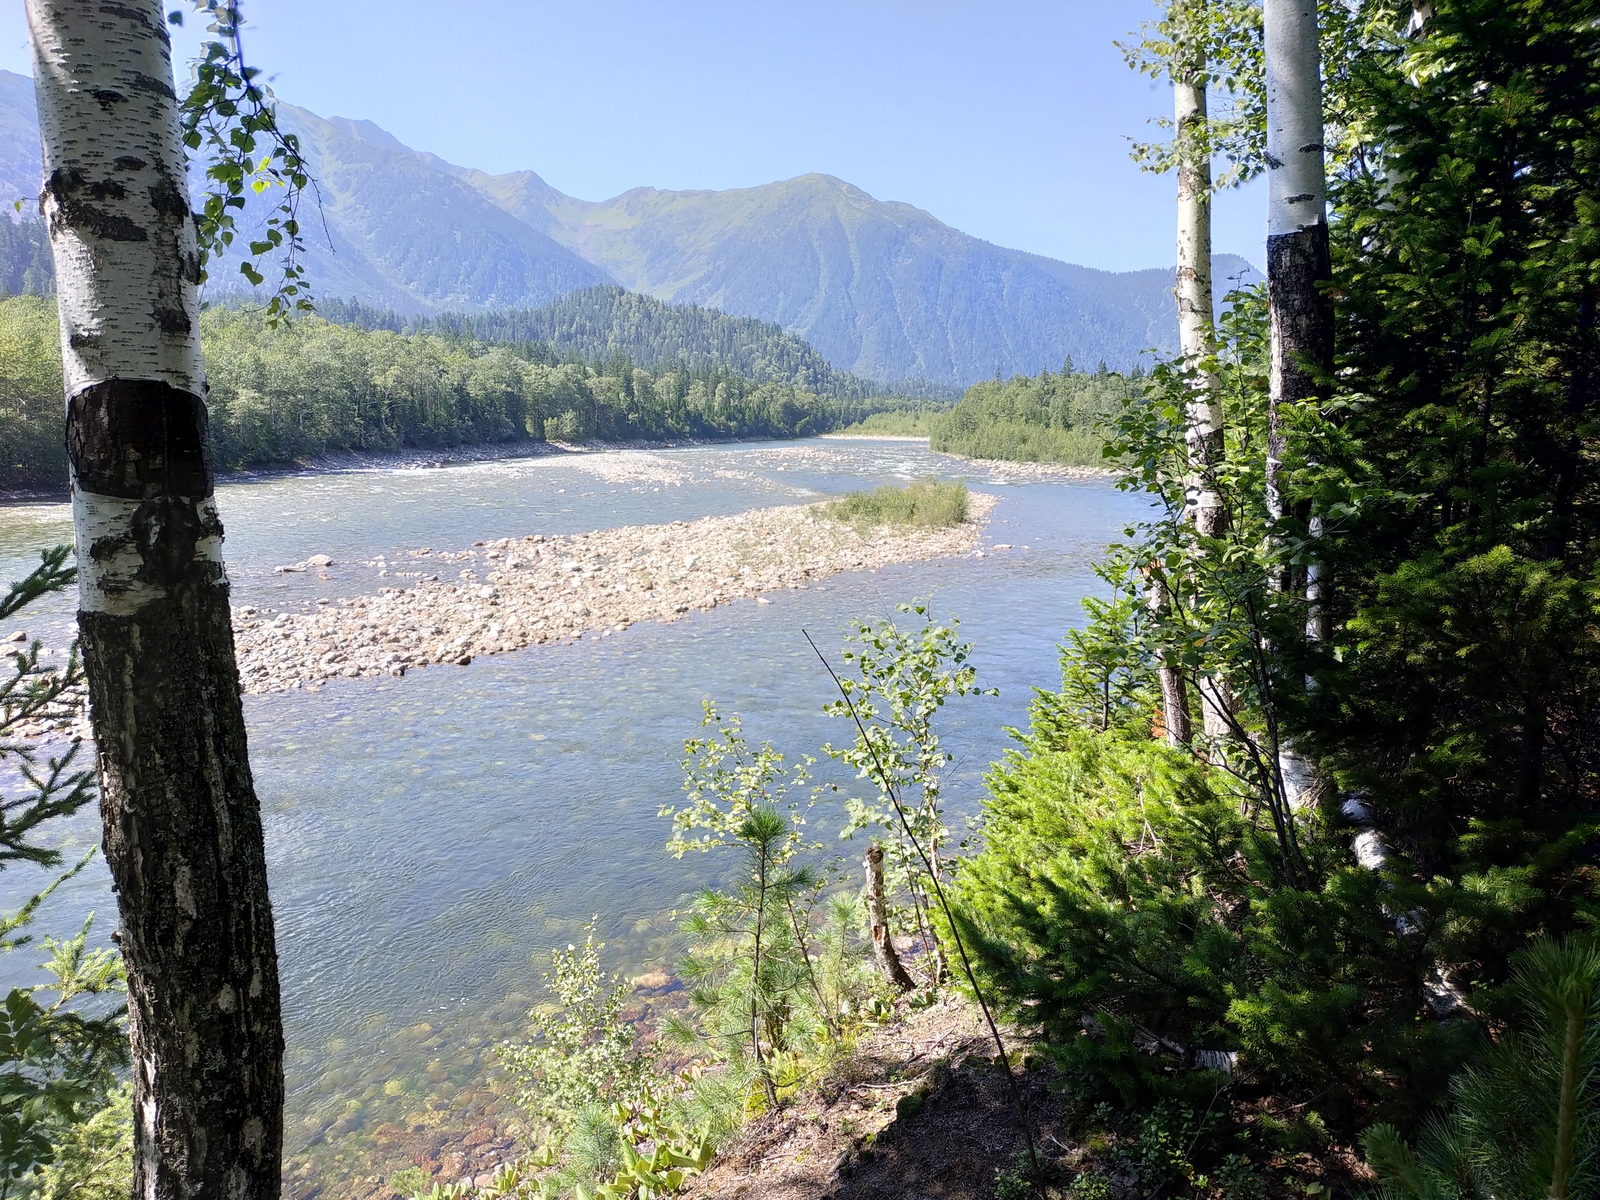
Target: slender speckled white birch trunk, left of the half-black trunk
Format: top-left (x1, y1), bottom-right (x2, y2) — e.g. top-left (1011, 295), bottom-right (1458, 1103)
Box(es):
top-left (1163, 9), bottom-right (1234, 752)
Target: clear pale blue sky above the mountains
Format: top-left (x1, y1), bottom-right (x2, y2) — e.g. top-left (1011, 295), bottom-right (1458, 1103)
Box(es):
top-left (0, 0), bottom-right (1264, 270)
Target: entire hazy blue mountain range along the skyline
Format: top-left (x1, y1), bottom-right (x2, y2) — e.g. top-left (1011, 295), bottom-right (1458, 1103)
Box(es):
top-left (0, 72), bottom-right (1246, 384)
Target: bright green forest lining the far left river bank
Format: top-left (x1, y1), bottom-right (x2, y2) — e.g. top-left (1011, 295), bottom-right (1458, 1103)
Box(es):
top-left (0, 296), bottom-right (928, 488)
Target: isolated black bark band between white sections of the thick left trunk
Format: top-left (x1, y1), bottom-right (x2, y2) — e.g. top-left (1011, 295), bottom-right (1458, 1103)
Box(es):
top-left (67, 379), bottom-right (211, 501)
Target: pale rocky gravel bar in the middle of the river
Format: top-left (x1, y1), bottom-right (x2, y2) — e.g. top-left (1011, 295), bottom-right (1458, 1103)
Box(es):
top-left (234, 494), bottom-right (997, 693)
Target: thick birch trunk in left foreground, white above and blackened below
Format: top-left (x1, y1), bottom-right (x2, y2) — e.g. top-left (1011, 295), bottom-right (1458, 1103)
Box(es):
top-left (27, 0), bottom-right (283, 1200)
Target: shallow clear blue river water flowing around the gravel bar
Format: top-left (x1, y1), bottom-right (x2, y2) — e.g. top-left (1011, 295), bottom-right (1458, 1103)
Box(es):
top-left (0, 438), bottom-right (1141, 1196)
